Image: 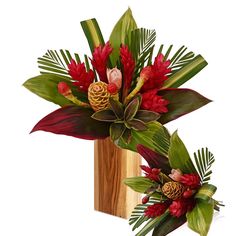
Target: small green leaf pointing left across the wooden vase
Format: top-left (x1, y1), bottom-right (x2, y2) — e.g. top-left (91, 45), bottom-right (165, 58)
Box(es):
top-left (124, 176), bottom-right (153, 193)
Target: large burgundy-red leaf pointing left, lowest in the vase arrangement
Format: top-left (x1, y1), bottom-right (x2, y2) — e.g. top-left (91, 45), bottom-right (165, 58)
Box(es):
top-left (31, 106), bottom-right (110, 140)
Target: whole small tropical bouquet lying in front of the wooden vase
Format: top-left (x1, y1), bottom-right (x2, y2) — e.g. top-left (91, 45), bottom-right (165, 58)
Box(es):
top-left (124, 132), bottom-right (223, 236)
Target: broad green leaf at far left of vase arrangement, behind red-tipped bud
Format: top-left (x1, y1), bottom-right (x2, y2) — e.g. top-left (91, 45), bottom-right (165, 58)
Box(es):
top-left (23, 74), bottom-right (87, 106)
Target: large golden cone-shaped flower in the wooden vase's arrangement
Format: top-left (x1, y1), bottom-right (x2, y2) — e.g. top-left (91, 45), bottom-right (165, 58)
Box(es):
top-left (88, 81), bottom-right (110, 111)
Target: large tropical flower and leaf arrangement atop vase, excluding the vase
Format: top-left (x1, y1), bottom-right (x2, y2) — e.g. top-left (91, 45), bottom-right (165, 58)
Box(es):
top-left (24, 9), bottom-right (210, 154)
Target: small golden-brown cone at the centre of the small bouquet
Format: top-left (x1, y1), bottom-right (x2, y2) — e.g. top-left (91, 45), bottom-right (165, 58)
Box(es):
top-left (162, 181), bottom-right (185, 200)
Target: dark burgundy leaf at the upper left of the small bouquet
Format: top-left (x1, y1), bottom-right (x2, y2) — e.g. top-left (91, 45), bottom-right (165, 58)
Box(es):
top-left (137, 144), bottom-right (171, 175)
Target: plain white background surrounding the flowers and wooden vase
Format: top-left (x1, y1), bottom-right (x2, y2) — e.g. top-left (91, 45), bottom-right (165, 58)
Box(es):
top-left (0, 0), bottom-right (236, 236)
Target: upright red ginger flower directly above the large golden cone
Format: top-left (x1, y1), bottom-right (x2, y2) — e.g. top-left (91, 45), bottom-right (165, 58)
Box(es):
top-left (91, 42), bottom-right (112, 83)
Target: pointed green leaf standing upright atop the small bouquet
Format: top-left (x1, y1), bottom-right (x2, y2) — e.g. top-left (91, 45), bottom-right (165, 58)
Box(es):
top-left (168, 131), bottom-right (197, 173)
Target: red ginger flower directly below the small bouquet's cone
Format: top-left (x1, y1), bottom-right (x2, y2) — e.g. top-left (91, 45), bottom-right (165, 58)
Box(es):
top-left (169, 198), bottom-right (195, 217)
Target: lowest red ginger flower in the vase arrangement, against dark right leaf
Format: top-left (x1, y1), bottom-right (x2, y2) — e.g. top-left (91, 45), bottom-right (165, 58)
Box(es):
top-left (141, 89), bottom-right (169, 113)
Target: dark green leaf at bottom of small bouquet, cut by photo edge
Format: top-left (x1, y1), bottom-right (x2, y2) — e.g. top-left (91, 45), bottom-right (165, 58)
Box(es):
top-left (152, 212), bottom-right (186, 236)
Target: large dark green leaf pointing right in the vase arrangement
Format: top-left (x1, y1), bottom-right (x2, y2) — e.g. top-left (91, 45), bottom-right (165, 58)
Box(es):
top-left (158, 88), bottom-right (211, 124)
